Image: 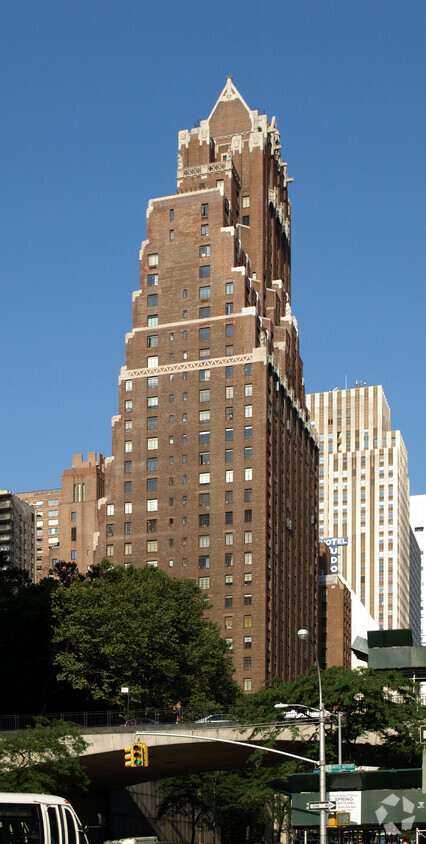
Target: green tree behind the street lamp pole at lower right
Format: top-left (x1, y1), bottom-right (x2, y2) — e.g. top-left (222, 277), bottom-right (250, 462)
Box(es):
top-left (238, 667), bottom-right (425, 768)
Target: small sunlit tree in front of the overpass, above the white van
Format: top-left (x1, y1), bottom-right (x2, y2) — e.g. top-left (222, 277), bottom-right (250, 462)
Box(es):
top-left (0, 719), bottom-right (89, 794)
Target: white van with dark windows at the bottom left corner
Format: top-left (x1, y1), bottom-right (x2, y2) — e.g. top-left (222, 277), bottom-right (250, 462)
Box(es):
top-left (0, 792), bottom-right (88, 844)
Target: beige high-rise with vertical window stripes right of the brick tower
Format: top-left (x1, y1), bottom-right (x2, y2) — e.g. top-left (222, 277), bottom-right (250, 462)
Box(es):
top-left (306, 386), bottom-right (410, 629)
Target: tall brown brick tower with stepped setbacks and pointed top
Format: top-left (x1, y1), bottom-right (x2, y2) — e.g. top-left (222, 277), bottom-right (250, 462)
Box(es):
top-left (97, 78), bottom-right (318, 691)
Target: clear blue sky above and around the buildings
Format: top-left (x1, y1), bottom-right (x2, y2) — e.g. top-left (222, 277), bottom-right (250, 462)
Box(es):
top-left (0, 0), bottom-right (426, 493)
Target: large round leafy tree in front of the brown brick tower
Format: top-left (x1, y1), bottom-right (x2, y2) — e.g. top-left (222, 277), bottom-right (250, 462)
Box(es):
top-left (52, 566), bottom-right (238, 707)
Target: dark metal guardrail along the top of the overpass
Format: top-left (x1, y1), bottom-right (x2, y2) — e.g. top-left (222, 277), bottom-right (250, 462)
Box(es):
top-left (0, 707), bottom-right (233, 732)
